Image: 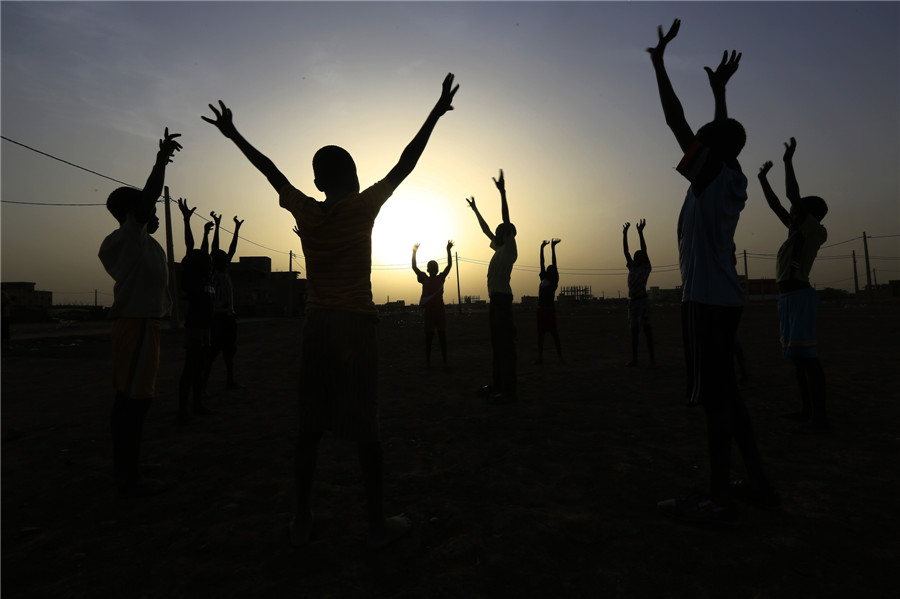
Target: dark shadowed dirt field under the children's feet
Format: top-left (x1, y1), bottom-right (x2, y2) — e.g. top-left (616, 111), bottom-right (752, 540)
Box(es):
top-left (2, 303), bottom-right (900, 599)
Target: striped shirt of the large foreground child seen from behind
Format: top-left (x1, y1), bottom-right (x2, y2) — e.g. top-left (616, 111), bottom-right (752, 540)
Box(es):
top-left (278, 179), bottom-right (394, 314)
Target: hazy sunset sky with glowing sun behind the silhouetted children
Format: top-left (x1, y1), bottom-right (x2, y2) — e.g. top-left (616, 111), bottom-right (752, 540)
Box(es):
top-left (0, 1), bottom-right (900, 305)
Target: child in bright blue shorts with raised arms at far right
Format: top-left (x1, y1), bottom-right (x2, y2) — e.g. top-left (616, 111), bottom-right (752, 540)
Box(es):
top-left (759, 137), bottom-right (831, 433)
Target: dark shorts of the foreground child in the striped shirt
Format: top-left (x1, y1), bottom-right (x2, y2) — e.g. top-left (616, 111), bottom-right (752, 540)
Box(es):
top-left (298, 309), bottom-right (380, 441)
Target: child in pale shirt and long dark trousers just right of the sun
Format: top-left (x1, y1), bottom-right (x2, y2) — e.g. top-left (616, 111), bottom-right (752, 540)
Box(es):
top-left (466, 169), bottom-right (519, 404)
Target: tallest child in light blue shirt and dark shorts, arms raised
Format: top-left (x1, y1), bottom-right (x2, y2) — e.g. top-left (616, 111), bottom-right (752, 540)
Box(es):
top-left (647, 19), bottom-right (778, 524)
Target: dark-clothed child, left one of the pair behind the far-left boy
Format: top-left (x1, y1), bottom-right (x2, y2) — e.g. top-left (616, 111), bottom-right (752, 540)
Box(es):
top-left (178, 198), bottom-right (216, 424)
